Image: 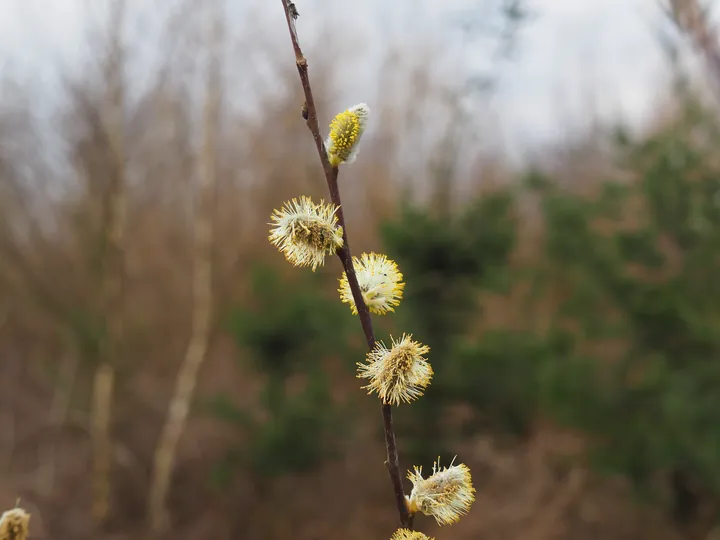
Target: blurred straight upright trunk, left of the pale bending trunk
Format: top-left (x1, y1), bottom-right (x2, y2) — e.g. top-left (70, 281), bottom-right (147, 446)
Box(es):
top-left (92, 0), bottom-right (126, 523)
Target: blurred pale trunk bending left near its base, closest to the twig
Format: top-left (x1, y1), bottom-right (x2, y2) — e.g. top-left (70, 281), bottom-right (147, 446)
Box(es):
top-left (148, 2), bottom-right (222, 532)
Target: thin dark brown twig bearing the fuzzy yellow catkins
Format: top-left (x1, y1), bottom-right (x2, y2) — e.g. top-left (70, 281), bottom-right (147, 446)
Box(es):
top-left (282, 0), bottom-right (412, 528)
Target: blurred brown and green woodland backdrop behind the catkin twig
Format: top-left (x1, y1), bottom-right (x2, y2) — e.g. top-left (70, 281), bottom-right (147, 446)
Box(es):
top-left (0, 1), bottom-right (720, 539)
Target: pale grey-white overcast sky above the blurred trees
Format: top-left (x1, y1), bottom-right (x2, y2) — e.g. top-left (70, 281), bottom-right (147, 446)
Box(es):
top-left (0, 0), bottom-right (684, 156)
